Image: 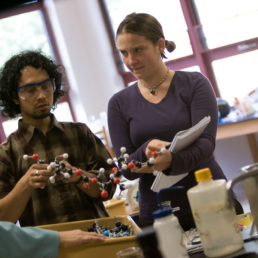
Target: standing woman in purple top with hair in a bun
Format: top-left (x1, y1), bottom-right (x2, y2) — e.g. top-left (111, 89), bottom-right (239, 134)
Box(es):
top-left (108, 13), bottom-right (242, 230)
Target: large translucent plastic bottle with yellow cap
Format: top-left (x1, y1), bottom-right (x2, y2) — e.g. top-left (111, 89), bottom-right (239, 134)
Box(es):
top-left (187, 168), bottom-right (243, 257)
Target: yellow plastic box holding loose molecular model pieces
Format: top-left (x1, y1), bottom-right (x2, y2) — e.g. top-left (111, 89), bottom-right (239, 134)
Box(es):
top-left (38, 216), bottom-right (141, 258)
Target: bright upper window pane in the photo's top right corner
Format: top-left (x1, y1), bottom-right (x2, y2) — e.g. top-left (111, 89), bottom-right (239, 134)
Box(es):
top-left (194, 0), bottom-right (258, 48)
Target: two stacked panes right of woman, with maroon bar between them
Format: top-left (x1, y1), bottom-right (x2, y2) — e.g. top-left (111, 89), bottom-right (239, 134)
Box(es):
top-left (194, 0), bottom-right (258, 105)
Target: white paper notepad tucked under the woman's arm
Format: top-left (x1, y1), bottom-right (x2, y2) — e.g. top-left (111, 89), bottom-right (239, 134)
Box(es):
top-left (151, 116), bottom-right (211, 192)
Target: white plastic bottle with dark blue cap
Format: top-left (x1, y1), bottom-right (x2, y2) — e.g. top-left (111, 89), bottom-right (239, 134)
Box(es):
top-left (153, 207), bottom-right (189, 258)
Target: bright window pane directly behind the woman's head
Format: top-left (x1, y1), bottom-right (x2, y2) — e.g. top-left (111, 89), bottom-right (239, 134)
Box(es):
top-left (105, 0), bottom-right (193, 63)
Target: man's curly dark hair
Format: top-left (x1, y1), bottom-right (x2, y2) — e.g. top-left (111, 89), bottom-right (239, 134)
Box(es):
top-left (0, 51), bottom-right (65, 118)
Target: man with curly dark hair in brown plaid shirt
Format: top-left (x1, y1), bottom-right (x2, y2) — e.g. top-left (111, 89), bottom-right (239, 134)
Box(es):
top-left (0, 51), bottom-right (115, 226)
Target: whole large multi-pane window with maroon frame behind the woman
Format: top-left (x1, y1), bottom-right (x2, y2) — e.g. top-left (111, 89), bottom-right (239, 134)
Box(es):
top-left (100, 0), bottom-right (258, 105)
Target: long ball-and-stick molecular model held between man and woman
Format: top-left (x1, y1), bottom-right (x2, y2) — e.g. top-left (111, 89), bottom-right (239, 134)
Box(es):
top-left (23, 147), bottom-right (165, 198)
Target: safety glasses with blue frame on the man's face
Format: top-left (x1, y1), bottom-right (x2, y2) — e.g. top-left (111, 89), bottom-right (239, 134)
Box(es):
top-left (16, 78), bottom-right (56, 98)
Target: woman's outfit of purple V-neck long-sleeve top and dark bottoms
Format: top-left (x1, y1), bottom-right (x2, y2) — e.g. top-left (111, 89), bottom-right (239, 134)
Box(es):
top-left (108, 71), bottom-right (225, 222)
